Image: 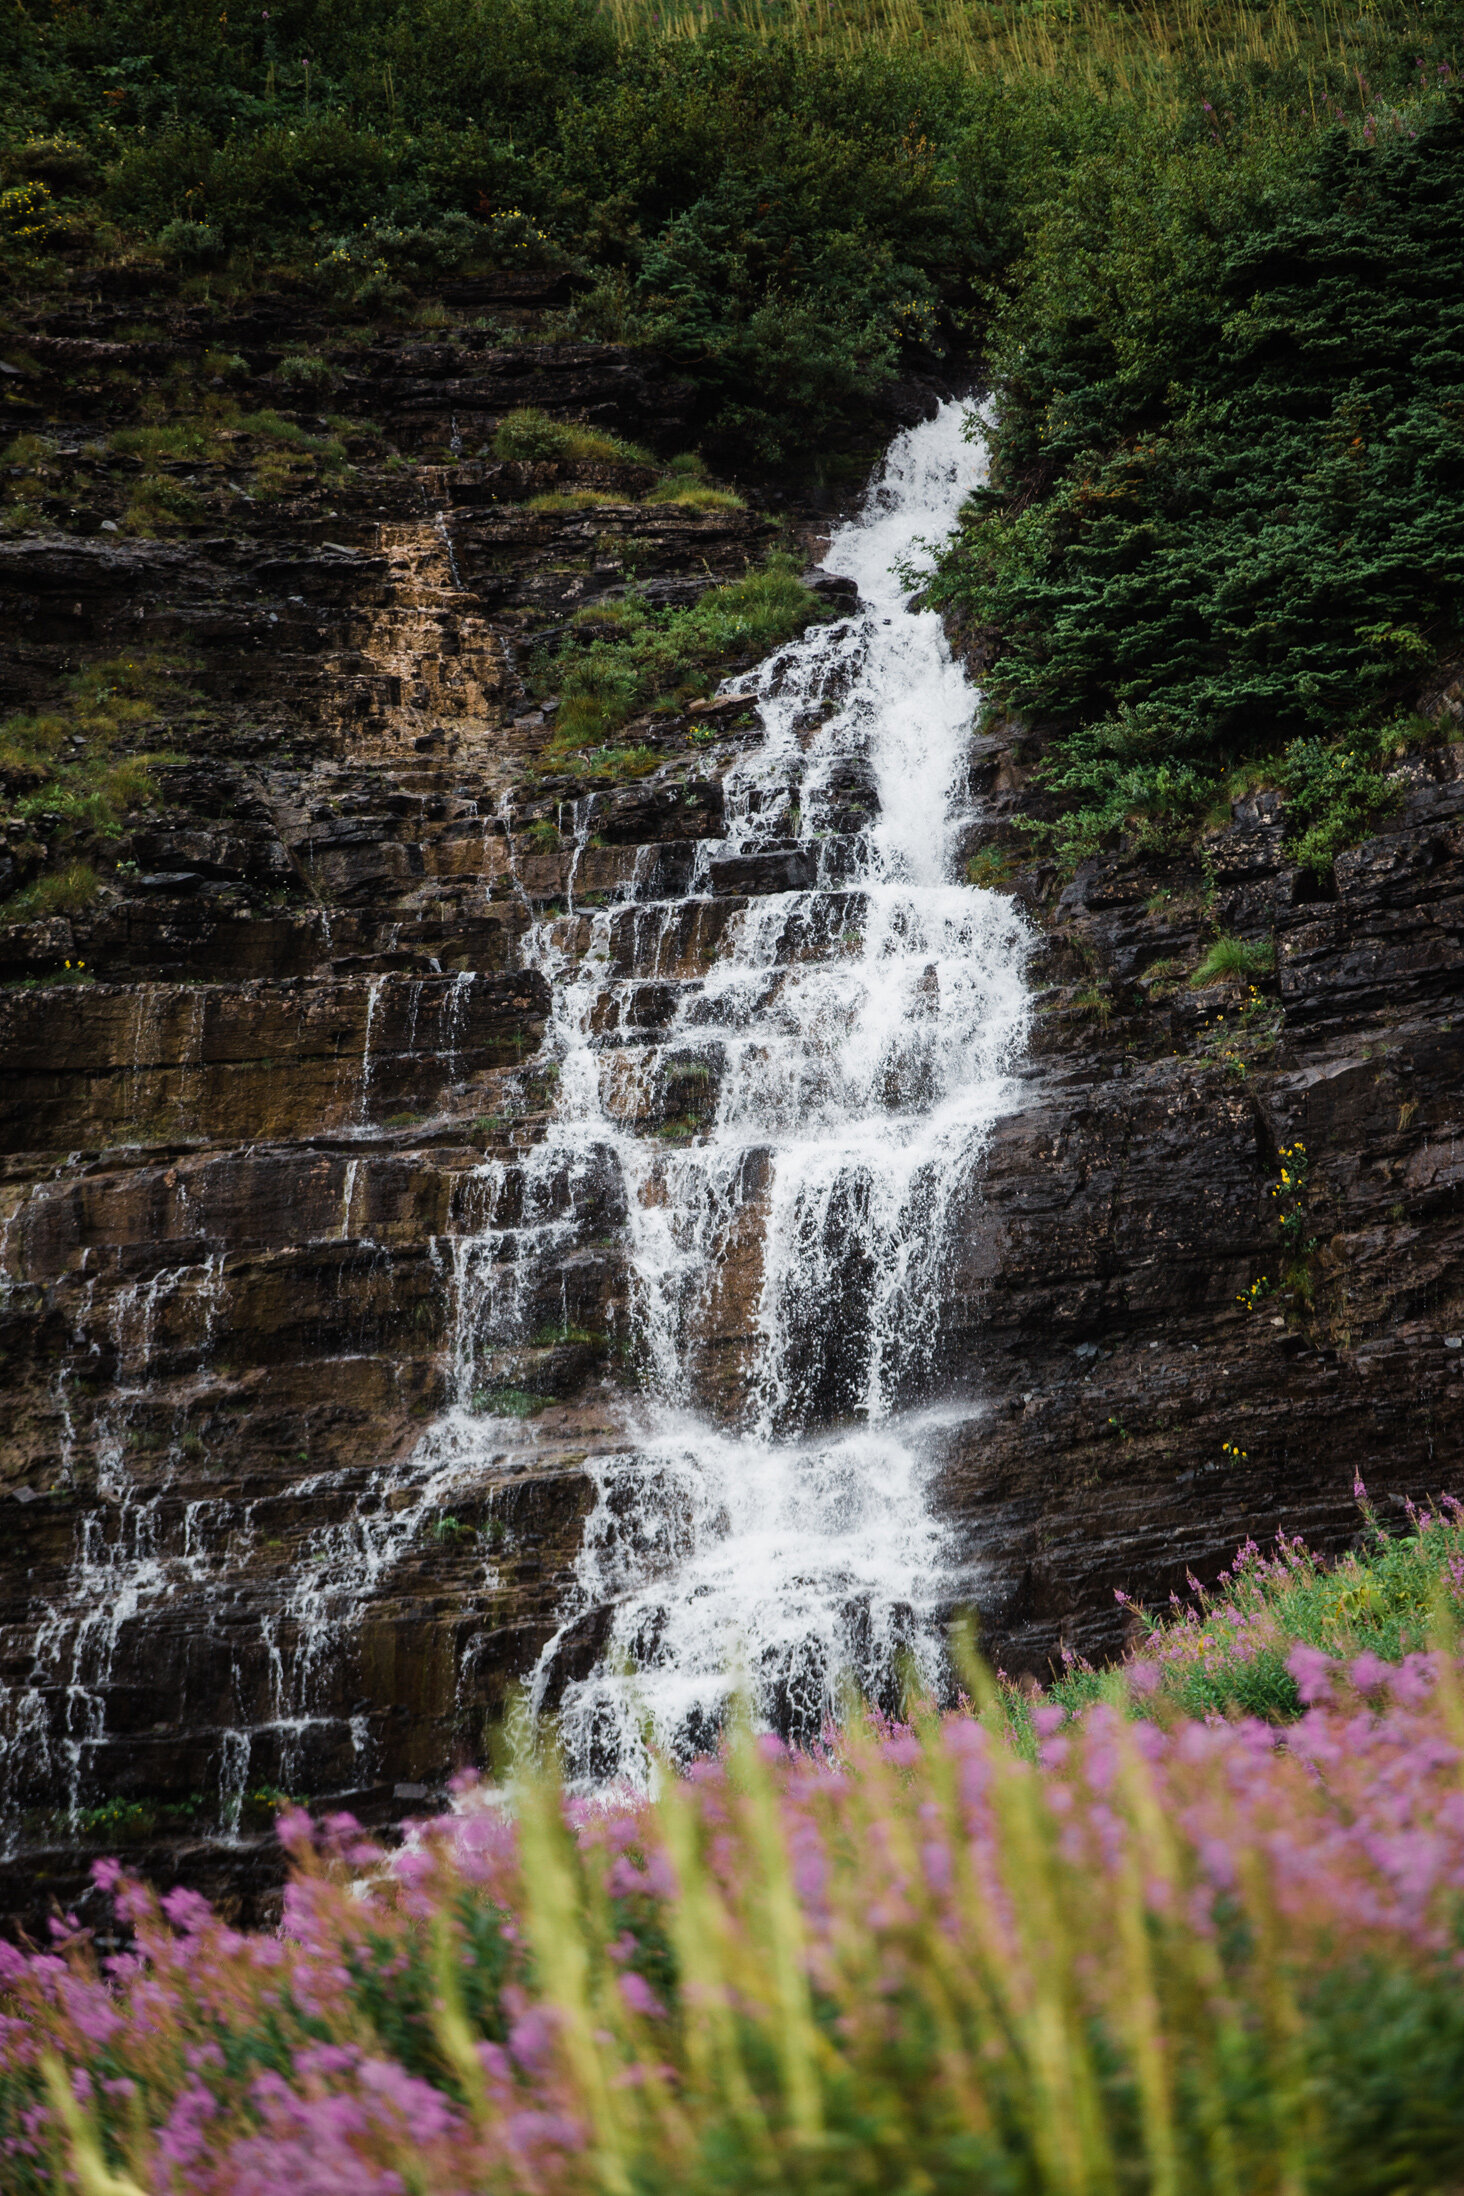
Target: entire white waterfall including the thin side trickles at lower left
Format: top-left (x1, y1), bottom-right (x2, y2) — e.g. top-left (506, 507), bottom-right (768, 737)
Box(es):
top-left (0, 404), bottom-right (1027, 1849)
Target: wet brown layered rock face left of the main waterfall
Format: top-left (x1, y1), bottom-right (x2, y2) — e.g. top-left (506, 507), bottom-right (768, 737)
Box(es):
top-left (0, 283), bottom-right (801, 1924)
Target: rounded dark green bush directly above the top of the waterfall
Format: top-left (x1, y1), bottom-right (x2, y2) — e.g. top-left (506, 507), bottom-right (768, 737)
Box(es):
top-left (544, 31), bottom-right (966, 463)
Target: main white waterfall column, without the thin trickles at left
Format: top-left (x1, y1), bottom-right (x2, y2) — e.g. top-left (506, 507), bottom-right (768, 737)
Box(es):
top-left (498, 404), bottom-right (1025, 1781)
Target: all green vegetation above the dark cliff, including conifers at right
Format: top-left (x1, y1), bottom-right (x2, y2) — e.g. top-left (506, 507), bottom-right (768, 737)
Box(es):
top-left (0, 0), bottom-right (1464, 825)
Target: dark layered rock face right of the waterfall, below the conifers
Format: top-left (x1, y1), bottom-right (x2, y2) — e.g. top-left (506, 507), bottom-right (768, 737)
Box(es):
top-left (942, 727), bottom-right (1464, 1671)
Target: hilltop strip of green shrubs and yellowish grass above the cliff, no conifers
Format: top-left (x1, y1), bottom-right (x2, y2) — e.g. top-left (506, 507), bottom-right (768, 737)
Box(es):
top-left (0, 0), bottom-right (1438, 463)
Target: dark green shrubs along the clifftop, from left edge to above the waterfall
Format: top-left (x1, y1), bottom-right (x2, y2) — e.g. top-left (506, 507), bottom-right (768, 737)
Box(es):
top-left (0, 0), bottom-right (1009, 459)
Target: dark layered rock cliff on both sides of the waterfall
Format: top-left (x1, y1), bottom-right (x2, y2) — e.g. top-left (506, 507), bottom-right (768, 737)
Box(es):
top-left (0, 283), bottom-right (1464, 1917)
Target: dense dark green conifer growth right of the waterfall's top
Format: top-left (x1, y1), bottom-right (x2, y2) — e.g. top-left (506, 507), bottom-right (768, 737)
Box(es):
top-left (935, 66), bottom-right (1464, 867)
